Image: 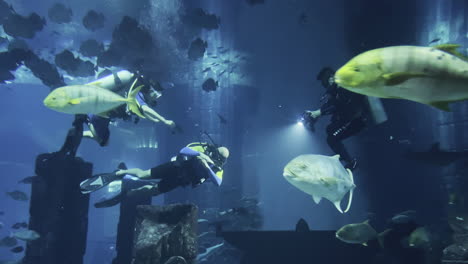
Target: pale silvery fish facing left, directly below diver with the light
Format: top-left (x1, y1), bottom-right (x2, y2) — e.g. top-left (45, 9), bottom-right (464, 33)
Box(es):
top-left (283, 154), bottom-right (356, 213)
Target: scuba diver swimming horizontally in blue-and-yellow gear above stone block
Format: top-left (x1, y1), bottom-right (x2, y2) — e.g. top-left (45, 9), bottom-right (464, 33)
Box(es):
top-left (80, 142), bottom-right (229, 208)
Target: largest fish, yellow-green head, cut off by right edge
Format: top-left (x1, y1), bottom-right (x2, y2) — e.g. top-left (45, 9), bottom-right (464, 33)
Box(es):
top-left (335, 44), bottom-right (468, 111)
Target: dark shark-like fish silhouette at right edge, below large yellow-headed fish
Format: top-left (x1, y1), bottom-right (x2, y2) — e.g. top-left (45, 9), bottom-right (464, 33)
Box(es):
top-left (405, 143), bottom-right (468, 167)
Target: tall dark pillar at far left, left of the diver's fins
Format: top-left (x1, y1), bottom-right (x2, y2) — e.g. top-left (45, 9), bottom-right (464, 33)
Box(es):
top-left (23, 153), bottom-right (92, 264)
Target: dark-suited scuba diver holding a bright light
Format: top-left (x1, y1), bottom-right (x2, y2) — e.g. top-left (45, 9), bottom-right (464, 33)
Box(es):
top-left (302, 67), bottom-right (387, 170)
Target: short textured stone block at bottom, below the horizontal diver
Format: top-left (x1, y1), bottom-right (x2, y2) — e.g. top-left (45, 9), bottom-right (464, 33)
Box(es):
top-left (132, 204), bottom-right (198, 264)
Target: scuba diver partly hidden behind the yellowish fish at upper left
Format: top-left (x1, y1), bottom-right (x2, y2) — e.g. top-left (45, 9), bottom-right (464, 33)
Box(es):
top-left (83, 70), bottom-right (182, 146)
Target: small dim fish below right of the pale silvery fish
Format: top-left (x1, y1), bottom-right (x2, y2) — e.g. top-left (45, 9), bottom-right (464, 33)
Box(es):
top-left (335, 220), bottom-right (389, 247)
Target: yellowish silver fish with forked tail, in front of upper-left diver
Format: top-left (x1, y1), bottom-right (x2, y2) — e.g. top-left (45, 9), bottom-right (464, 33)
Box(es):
top-left (44, 82), bottom-right (145, 118)
